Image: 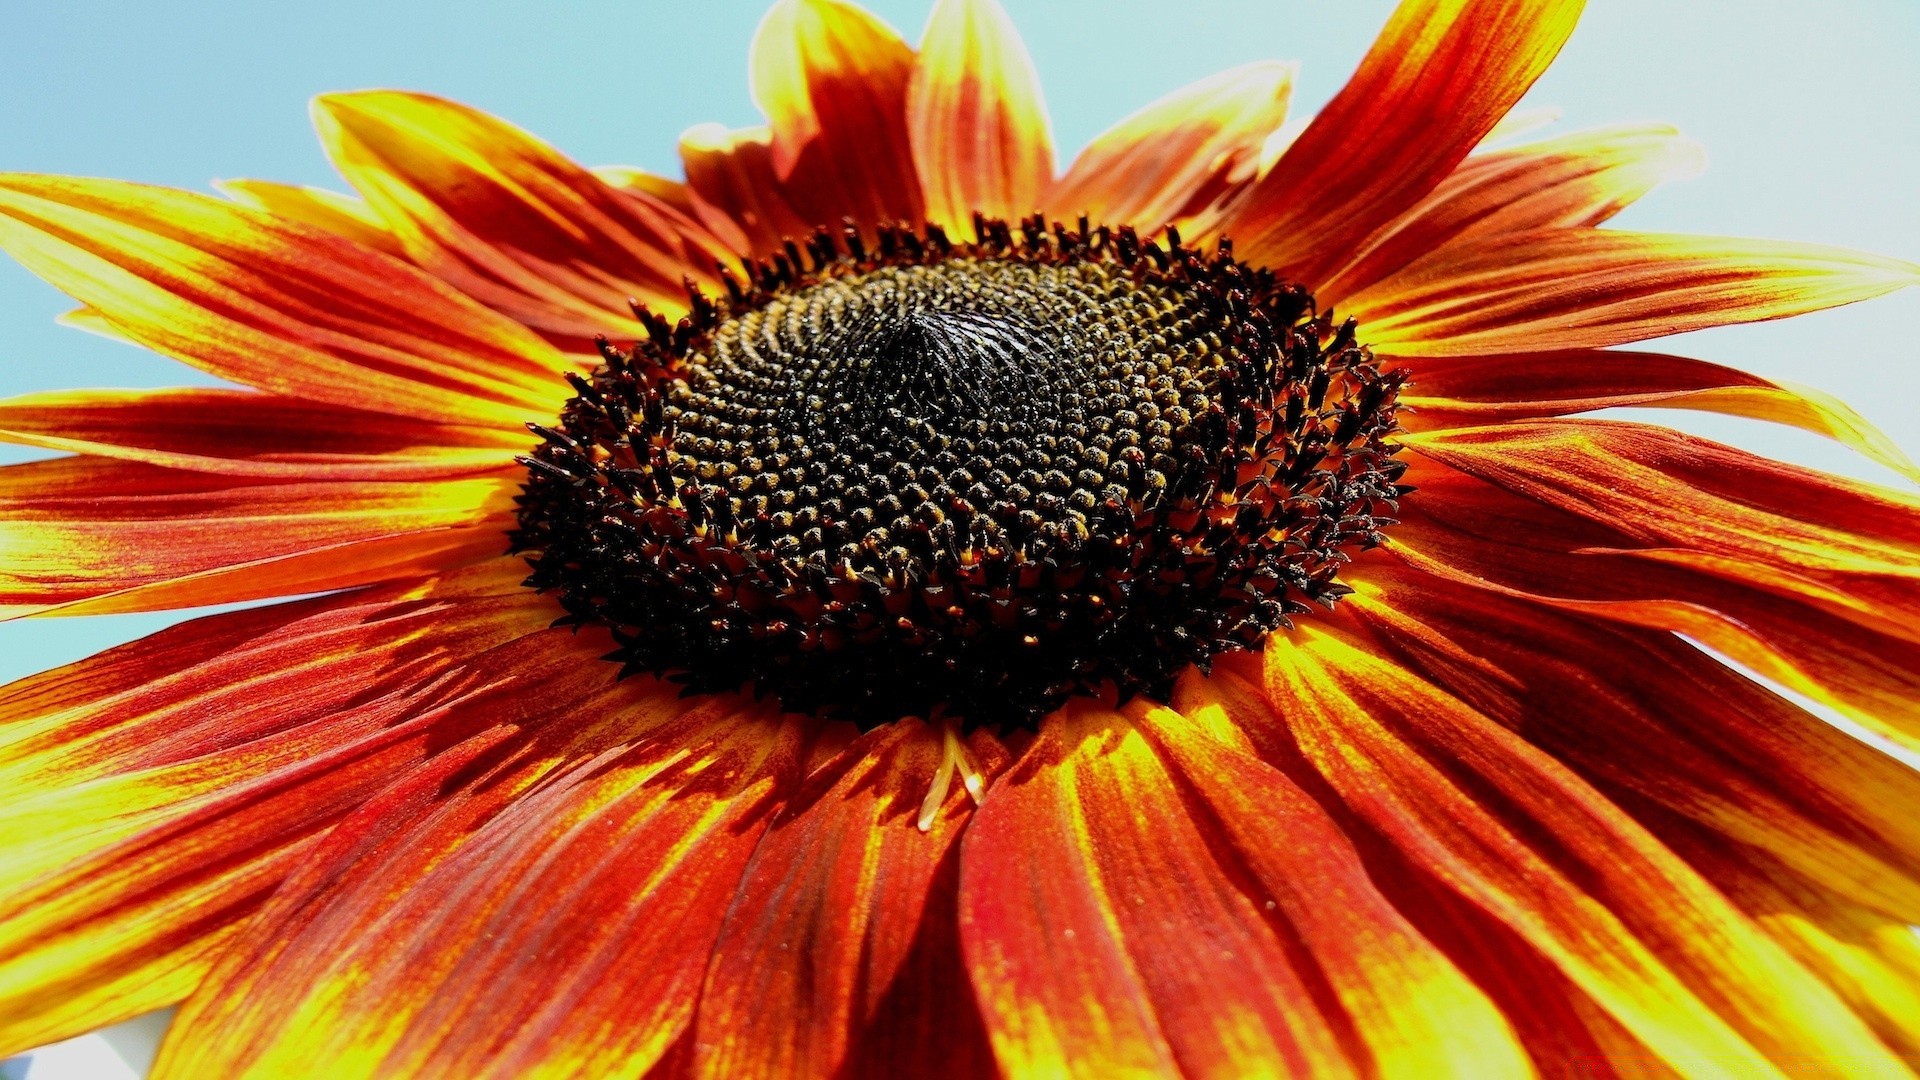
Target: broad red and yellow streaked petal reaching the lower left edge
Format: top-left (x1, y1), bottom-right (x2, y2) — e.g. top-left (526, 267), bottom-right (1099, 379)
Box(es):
top-left (0, 561), bottom-right (560, 1055)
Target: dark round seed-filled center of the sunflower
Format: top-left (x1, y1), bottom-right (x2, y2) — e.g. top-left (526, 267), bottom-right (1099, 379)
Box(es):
top-left (515, 219), bottom-right (1404, 726)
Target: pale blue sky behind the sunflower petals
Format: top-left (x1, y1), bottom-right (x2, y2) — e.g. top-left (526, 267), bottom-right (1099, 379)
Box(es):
top-left (11, 0), bottom-right (1920, 1080)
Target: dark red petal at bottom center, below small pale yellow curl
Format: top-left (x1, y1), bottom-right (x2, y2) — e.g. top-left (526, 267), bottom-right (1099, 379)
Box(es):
top-left (695, 721), bottom-right (1006, 1076)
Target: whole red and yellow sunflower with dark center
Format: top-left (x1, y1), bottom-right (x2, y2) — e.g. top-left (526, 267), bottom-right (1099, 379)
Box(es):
top-left (0, 0), bottom-right (1920, 1078)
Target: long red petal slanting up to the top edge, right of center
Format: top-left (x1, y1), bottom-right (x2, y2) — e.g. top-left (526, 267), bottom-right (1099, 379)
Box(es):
top-left (1221, 0), bottom-right (1582, 288)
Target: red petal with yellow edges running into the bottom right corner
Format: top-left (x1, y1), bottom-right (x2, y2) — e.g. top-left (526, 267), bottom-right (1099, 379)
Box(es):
top-left (1265, 621), bottom-right (1897, 1072)
